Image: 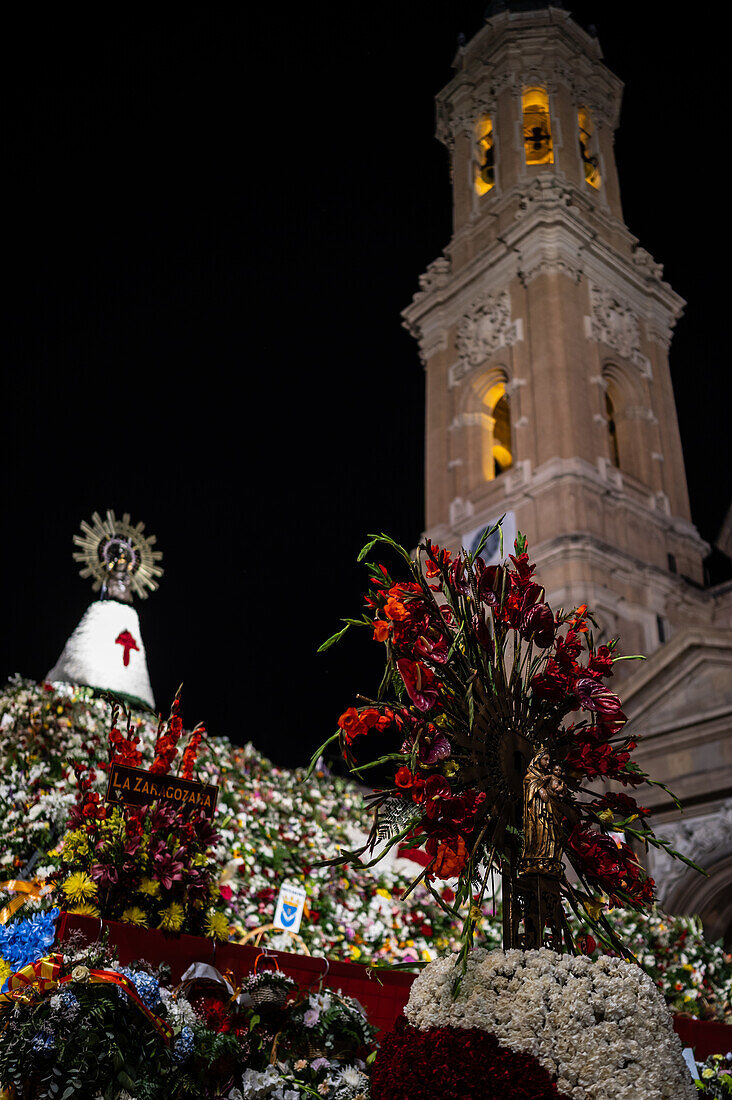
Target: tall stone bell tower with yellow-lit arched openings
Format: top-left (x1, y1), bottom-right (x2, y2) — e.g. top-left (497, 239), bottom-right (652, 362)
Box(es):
top-left (403, 0), bottom-right (708, 668)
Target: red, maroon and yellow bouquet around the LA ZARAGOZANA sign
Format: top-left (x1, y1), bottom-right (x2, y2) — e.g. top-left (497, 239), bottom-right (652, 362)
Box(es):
top-left (48, 697), bottom-right (229, 939)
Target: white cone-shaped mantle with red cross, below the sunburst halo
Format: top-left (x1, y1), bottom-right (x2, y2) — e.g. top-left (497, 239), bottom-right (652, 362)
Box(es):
top-left (46, 600), bottom-right (155, 708)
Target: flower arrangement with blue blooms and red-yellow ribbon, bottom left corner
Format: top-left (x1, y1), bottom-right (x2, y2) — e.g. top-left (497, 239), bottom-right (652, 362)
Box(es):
top-left (0, 942), bottom-right (250, 1100)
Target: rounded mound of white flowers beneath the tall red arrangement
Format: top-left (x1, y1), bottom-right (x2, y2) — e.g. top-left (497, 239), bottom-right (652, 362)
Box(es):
top-left (404, 949), bottom-right (697, 1100)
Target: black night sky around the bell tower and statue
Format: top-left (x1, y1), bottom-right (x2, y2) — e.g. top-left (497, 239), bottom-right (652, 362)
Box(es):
top-left (0, 0), bottom-right (730, 765)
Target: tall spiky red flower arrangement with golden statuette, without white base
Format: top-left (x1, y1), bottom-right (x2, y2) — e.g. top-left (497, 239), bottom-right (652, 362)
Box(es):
top-left (312, 528), bottom-right (695, 959)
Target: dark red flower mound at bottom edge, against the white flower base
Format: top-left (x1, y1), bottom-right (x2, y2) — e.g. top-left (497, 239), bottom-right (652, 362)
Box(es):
top-left (371, 1016), bottom-right (567, 1100)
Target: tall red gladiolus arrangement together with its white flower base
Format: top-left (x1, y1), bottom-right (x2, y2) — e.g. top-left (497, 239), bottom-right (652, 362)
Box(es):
top-left (312, 525), bottom-right (695, 1100)
